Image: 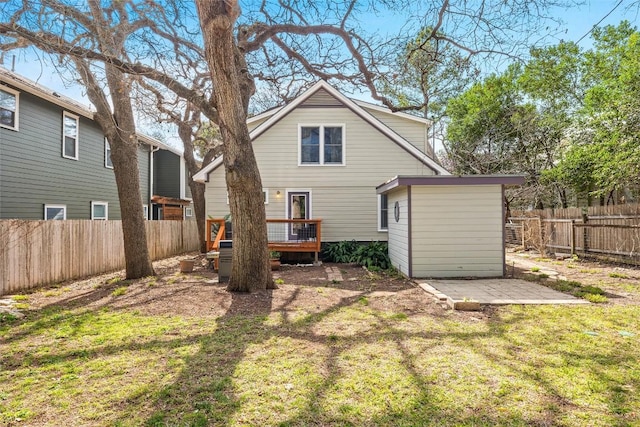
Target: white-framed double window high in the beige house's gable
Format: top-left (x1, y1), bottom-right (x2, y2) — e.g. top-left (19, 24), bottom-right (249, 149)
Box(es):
top-left (299, 125), bottom-right (344, 165)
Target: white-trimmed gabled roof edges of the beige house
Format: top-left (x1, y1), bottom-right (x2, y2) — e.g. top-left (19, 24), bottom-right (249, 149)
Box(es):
top-left (193, 80), bottom-right (450, 182)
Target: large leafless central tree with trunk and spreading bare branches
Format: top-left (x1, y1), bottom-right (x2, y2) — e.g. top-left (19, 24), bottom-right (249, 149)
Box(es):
top-left (0, 0), bottom-right (558, 291)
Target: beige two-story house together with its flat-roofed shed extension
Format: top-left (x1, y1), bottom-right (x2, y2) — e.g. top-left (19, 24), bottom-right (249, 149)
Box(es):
top-left (194, 81), bottom-right (524, 277)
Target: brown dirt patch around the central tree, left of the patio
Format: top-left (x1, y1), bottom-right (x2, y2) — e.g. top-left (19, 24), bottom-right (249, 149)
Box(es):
top-left (18, 256), bottom-right (460, 317)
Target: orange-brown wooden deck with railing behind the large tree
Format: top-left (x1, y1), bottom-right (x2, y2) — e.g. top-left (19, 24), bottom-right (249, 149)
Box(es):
top-left (207, 218), bottom-right (322, 262)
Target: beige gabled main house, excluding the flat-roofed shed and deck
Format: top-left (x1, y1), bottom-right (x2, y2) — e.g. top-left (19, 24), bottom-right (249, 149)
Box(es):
top-left (194, 81), bottom-right (449, 242)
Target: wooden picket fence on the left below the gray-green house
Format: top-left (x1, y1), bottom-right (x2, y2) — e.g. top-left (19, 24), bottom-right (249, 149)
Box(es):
top-left (0, 220), bottom-right (199, 295)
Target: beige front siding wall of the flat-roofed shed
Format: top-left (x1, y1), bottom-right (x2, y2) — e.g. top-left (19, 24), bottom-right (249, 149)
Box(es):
top-left (411, 185), bottom-right (504, 277)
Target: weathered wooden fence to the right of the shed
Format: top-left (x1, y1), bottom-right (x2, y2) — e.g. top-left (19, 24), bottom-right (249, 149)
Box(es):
top-left (506, 204), bottom-right (640, 264)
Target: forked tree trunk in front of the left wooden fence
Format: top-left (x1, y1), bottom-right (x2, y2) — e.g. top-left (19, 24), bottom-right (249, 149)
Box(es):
top-left (75, 59), bottom-right (155, 279)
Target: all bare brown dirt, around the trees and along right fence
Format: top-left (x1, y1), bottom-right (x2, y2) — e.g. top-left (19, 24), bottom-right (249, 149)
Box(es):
top-left (12, 252), bottom-right (640, 320)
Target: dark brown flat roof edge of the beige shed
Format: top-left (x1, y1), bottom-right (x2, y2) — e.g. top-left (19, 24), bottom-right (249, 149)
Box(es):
top-left (376, 175), bottom-right (525, 194)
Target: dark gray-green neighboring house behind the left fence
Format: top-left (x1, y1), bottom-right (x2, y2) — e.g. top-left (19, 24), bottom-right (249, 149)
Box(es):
top-left (0, 67), bottom-right (192, 220)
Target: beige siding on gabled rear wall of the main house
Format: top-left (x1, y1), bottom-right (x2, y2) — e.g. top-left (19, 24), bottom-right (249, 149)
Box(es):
top-left (206, 107), bottom-right (434, 241)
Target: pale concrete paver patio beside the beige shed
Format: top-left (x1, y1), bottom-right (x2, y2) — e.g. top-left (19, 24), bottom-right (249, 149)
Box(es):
top-left (418, 279), bottom-right (589, 306)
